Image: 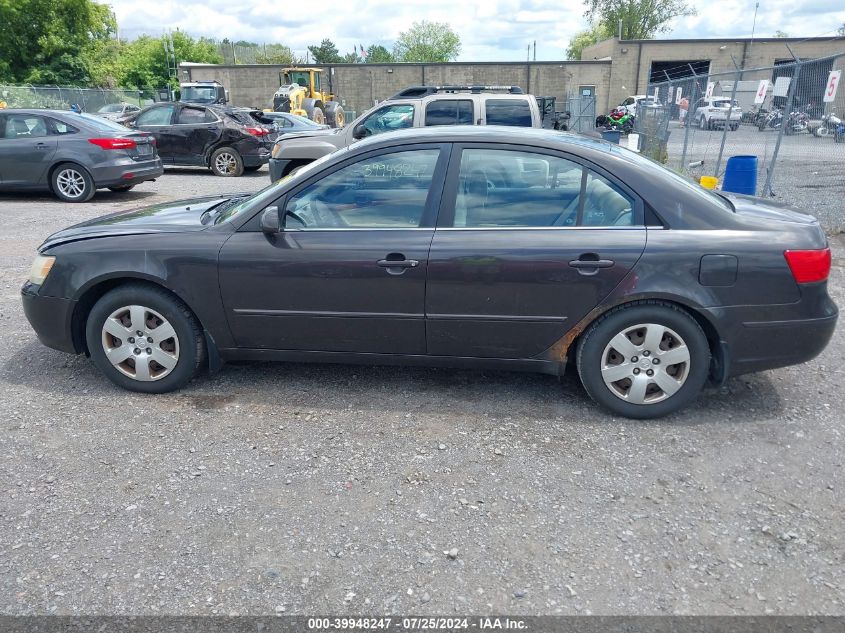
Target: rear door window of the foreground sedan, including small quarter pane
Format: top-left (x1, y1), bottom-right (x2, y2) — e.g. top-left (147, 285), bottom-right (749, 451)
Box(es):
top-left (453, 149), bottom-right (634, 228)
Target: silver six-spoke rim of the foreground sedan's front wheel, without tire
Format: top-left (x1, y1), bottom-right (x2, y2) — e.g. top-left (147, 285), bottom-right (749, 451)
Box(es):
top-left (102, 305), bottom-right (179, 382)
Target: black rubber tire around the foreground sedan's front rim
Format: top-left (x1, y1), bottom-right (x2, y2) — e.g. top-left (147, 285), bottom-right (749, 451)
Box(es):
top-left (85, 283), bottom-right (206, 393)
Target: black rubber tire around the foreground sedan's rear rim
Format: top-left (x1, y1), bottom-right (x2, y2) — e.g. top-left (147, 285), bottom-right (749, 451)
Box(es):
top-left (576, 301), bottom-right (710, 419)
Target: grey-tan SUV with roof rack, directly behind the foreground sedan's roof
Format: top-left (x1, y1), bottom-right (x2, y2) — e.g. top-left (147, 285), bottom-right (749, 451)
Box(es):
top-left (270, 86), bottom-right (543, 182)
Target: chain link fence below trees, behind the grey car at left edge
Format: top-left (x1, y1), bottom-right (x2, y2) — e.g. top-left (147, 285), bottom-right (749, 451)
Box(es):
top-left (0, 85), bottom-right (157, 112)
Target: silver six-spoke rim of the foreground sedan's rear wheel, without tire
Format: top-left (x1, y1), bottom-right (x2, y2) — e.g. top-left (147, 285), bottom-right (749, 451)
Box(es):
top-left (601, 323), bottom-right (690, 404)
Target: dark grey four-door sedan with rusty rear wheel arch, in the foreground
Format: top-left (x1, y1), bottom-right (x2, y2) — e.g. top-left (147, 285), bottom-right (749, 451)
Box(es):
top-left (22, 126), bottom-right (837, 418)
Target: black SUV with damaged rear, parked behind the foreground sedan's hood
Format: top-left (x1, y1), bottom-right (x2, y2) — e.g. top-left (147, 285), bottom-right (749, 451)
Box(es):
top-left (127, 102), bottom-right (276, 176)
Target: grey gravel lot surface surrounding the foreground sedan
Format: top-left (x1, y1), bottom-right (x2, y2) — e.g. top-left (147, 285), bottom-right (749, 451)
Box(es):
top-left (0, 165), bottom-right (845, 615)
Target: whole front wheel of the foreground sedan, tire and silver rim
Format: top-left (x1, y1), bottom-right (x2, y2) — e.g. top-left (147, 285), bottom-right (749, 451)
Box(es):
top-left (86, 284), bottom-right (205, 393)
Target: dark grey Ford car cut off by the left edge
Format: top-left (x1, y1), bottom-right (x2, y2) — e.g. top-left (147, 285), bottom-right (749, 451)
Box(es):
top-left (0, 109), bottom-right (164, 202)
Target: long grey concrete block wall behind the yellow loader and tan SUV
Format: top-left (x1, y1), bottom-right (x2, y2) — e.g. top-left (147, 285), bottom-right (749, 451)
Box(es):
top-left (179, 61), bottom-right (611, 121)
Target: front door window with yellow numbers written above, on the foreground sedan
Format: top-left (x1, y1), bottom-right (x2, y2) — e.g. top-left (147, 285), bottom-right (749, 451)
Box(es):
top-left (284, 149), bottom-right (440, 229)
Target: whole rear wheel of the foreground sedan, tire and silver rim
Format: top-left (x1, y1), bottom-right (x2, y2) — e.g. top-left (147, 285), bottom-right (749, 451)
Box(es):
top-left (577, 302), bottom-right (710, 418)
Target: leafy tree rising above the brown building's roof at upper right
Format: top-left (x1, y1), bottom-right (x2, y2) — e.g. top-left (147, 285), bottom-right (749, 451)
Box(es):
top-left (584, 0), bottom-right (696, 40)
